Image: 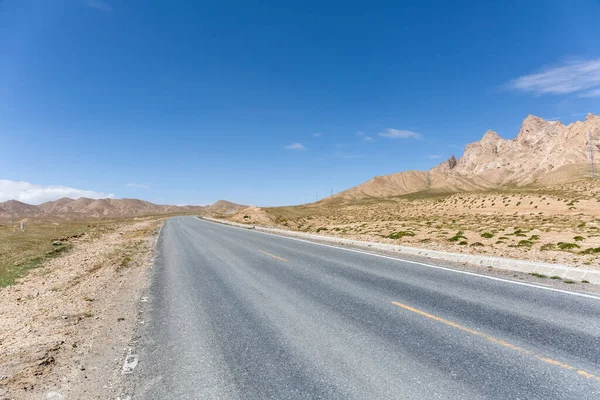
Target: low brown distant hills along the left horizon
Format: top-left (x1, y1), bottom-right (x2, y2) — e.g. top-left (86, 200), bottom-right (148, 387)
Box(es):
top-left (0, 197), bottom-right (205, 220)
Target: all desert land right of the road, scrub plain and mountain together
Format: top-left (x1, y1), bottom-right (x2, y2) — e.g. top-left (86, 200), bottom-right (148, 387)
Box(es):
top-left (222, 114), bottom-right (600, 269)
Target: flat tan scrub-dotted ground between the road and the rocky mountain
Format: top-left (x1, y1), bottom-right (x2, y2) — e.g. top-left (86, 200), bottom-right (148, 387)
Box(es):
top-left (228, 180), bottom-right (600, 269)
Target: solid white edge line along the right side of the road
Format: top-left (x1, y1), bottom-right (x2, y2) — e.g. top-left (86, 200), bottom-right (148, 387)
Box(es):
top-left (198, 218), bottom-right (600, 300)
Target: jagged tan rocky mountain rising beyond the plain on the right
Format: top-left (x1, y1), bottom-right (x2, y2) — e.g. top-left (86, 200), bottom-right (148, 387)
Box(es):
top-left (326, 114), bottom-right (600, 201)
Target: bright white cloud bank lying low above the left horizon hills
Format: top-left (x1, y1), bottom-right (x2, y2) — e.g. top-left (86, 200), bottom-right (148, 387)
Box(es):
top-left (0, 179), bottom-right (114, 204)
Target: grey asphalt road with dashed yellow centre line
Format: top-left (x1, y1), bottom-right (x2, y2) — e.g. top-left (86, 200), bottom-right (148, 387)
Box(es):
top-left (128, 217), bottom-right (600, 400)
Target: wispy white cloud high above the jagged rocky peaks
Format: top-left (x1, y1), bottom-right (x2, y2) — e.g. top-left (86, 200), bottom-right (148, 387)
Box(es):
top-left (507, 58), bottom-right (600, 97)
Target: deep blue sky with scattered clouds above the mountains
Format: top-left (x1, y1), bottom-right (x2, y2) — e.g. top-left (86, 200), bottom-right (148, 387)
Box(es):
top-left (0, 0), bottom-right (600, 205)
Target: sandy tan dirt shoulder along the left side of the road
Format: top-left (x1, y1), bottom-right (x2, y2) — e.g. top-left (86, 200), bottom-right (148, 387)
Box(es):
top-left (0, 219), bottom-right (162, 399)
